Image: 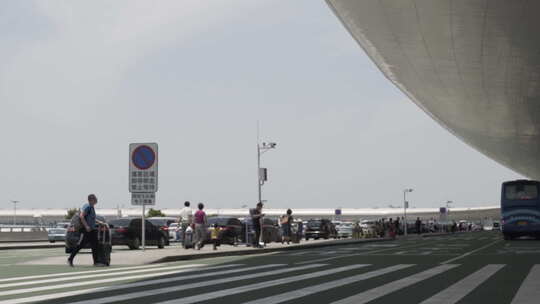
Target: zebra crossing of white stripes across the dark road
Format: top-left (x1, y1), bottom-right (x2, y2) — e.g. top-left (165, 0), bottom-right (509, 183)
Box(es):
top-left (0, 262), bottom-right (540, 304)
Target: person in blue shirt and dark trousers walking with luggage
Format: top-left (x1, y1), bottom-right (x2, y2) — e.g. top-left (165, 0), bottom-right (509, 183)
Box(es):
top-left (68, 194), bottom-right (105, 267)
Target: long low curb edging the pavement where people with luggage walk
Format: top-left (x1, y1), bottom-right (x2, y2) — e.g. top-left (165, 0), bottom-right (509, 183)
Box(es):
top-left (152, 238), bottom-right (392, 264)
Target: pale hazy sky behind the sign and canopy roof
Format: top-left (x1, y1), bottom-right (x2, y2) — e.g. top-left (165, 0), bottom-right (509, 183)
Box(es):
top-left (0, 0), bottom-right (521, 209)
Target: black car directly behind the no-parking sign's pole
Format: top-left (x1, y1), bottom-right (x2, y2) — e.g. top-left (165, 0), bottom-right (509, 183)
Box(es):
top-left (109, 218), bottom-right (169, 250)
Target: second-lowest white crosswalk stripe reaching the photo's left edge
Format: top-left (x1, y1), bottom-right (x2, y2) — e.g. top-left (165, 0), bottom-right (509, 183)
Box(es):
top-left (0, 267), bottom-right (232, 296)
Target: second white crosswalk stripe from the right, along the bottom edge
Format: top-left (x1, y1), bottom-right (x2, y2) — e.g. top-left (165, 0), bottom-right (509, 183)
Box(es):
top-left (421, 264), bottom-right (504, 304)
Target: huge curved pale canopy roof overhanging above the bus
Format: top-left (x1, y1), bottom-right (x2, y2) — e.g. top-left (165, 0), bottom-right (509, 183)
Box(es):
top-left (327, 0), bottom-right (540, 179)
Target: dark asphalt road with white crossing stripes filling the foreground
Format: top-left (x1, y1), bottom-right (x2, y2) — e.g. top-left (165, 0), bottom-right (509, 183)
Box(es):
top-left (0, 232), bottom-right (540, 304)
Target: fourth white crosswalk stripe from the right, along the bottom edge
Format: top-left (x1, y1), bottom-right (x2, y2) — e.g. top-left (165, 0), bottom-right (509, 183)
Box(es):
top-left (240, 264), bottom-right (414, 304)
